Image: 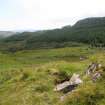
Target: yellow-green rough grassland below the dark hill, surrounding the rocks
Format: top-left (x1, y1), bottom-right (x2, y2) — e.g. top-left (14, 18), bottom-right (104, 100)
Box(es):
top-left (0, 47), bottom-right (105, 105)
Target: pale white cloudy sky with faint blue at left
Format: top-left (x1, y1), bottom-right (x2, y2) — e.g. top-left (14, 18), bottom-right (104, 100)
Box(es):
top-left (0, 0), bottom-right (105, 31)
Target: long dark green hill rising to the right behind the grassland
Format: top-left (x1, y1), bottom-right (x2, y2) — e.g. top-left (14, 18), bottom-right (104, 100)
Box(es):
top-left (0, 17), bottom-right (105, 50)
